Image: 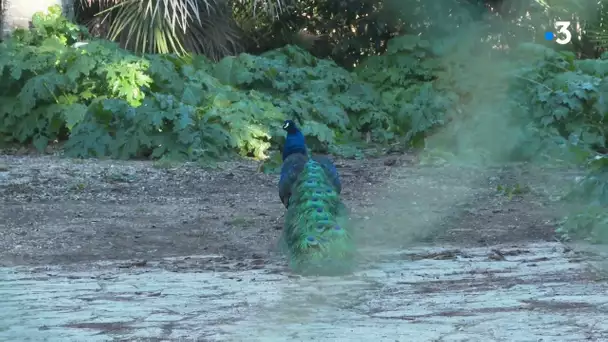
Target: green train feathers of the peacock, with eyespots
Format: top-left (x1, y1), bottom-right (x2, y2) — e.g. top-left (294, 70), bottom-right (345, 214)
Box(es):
top-left (283, 158), bottom-right (354, 275)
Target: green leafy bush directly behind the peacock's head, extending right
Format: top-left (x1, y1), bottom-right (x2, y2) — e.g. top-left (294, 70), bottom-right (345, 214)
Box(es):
top-left (213, 45), bottom-right (389, 149)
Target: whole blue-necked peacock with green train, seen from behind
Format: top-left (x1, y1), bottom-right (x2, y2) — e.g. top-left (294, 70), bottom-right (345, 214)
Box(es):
top-left (279, 120), bottom-right (355, 275)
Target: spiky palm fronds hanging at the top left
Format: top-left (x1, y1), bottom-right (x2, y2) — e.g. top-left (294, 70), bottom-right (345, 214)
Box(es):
top-left (79, 0), bottom-right (293, 60)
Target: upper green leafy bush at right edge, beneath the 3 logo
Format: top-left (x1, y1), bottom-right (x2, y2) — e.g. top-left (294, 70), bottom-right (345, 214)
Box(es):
top-left (512, 44), bottom-right (608, 159)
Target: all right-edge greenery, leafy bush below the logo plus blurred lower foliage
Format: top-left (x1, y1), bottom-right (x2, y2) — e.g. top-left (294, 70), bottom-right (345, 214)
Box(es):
top-left (511, 44), bottom-right (608, 243)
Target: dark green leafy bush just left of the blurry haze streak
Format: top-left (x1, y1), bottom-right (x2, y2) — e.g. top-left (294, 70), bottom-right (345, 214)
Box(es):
top-left (356, 35), bottom-right (448, 146)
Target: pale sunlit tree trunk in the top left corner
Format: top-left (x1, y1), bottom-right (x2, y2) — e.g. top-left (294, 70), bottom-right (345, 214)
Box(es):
top-left (0, 0), bottom-right (72, 38)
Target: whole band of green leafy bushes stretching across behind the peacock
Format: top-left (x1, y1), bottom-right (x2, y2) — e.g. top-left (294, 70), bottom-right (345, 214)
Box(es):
top-left (0, 7), bottom-right (608, 241)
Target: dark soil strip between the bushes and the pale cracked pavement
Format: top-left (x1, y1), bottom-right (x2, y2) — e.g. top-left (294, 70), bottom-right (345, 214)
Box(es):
top-left (0, 155), bottom-right (568, 265)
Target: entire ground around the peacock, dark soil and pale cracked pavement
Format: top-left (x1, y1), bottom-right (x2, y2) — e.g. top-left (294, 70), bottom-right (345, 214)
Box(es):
top-left (0, 156), bottom-right (608, 341)
